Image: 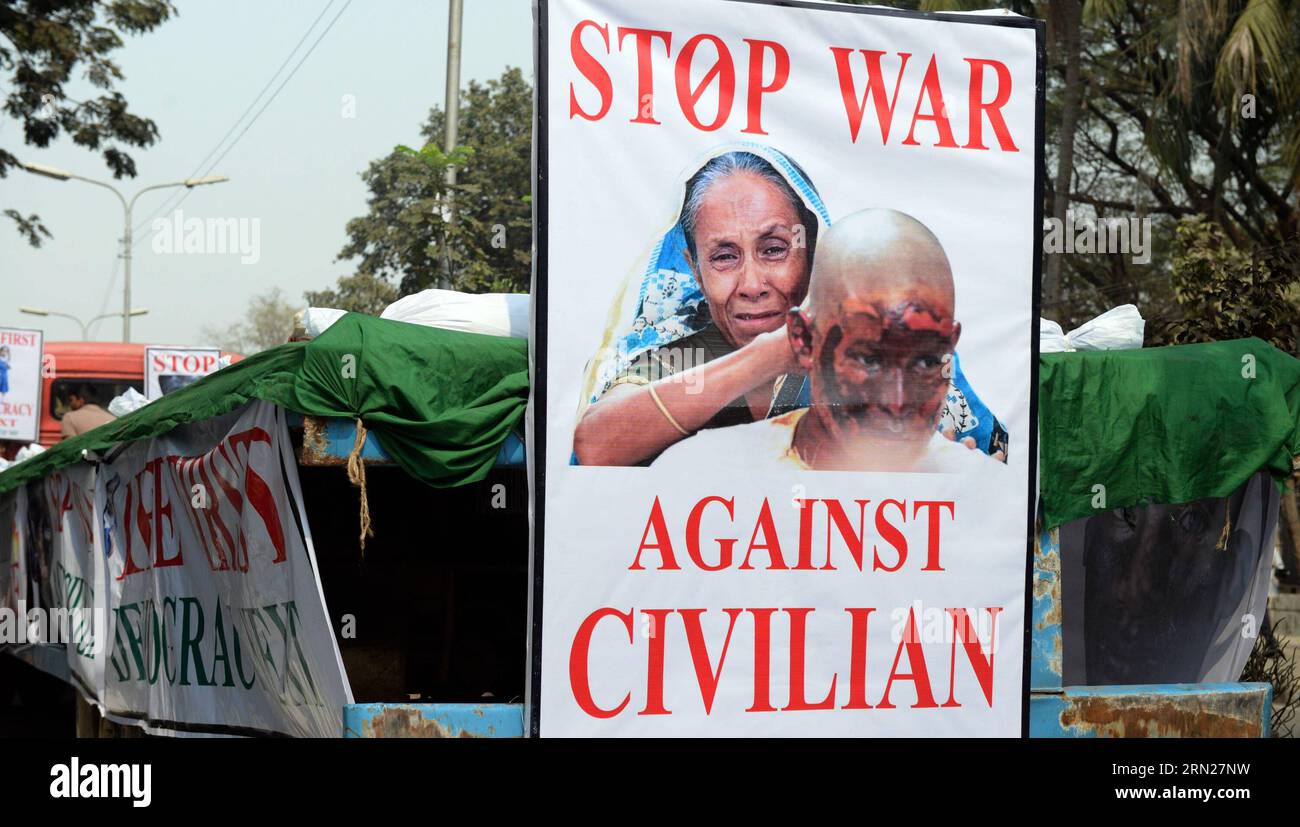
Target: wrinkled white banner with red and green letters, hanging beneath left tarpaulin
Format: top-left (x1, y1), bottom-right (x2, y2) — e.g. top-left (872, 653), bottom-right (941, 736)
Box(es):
top-left (95, 402), bottom-right (352, 737)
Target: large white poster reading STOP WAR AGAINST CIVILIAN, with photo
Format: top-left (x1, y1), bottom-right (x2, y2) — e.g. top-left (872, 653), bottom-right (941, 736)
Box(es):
top-left (528, 0), bottom-right (1044, 736)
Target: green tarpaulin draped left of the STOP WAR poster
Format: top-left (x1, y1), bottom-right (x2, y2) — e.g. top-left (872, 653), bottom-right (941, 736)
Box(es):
top-left (0, 313), bottom-right (528, 493)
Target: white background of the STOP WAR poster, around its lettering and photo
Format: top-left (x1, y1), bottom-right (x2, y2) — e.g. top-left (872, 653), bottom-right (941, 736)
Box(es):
top-left (530, 0), bottom-right (1039, 736)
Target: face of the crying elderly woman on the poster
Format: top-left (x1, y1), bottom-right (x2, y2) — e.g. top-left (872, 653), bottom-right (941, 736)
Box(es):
top-left (692, 172), bottom-right (811, 347)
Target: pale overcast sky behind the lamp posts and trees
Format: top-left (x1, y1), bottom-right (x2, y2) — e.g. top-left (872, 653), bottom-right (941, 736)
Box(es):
top-left (0, 0), bottom-right (532, 345)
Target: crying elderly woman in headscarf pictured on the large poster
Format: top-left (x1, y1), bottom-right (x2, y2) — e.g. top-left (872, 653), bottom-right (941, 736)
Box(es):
top-left (572, 143), bottom-right (1008, 466)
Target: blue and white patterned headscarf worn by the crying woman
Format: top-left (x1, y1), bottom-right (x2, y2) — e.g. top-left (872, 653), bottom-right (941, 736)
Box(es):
top-left (586, 142), bottom-right (1008, 454)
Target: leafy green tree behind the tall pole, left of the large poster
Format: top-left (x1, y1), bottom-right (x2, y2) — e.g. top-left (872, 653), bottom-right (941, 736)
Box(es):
top-left (338, 69), bottom-right (533, 295)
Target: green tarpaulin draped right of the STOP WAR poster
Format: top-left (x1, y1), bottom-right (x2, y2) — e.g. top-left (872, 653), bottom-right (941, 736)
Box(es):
top-left (1039, 339), bottom-right (1300, 528)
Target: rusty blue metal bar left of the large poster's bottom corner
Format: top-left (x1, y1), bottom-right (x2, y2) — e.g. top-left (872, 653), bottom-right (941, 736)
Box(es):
top-left (343, 703), bottom-right (524, 739)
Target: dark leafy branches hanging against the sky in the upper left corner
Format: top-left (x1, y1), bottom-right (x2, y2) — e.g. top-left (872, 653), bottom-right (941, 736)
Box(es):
top-left (0, 0), bottom-right (176, 247)
